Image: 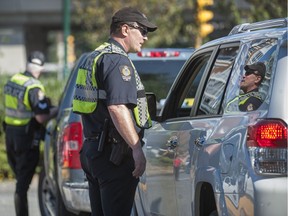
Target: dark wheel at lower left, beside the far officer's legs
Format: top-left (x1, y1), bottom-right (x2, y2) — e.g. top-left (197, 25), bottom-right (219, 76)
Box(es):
top-left (38, 169), bottom-right (56, 216)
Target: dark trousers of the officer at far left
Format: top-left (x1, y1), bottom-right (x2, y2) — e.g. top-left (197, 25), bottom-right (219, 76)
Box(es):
top-left (6, 127), bottom-right (39, 216)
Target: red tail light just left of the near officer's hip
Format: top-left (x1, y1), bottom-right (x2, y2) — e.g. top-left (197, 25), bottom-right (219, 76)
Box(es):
top-left (62, 122), bottom-right (83, 169)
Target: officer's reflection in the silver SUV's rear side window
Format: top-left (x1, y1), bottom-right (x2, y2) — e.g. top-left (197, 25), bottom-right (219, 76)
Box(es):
top-left (239, 62), bottom-right (266, 111)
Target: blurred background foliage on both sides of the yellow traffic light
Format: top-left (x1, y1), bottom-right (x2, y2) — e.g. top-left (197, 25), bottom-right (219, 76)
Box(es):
top-left (71, 0), bottom-right (287, 53)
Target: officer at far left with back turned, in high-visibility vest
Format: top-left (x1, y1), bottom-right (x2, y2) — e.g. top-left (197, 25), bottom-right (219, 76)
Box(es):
top-left (4, 51), bottom-right (58, 216)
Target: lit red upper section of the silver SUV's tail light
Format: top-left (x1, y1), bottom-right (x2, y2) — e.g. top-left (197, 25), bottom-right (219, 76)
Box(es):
top-left (248, 120), bottom-right (287, 148)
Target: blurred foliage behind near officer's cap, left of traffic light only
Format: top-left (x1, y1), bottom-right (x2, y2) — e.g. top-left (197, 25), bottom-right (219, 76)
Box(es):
top-left (71, 0), bottom-right (194, 55)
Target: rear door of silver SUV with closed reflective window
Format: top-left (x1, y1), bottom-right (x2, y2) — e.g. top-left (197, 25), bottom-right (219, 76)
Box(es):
top-left (175, 43), bottom-right (239, 215)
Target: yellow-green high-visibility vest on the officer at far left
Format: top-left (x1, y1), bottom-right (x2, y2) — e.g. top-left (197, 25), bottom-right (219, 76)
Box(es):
top-left (4, 73), bottom-right (45, 126)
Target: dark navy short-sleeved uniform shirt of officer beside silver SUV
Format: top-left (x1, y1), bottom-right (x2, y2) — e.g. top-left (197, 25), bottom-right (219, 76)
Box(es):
top-left (82, 39), bottom-right (140, 137)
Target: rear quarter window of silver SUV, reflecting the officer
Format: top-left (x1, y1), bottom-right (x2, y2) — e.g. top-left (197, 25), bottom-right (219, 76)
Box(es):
top-left (226, 38), bottom-right (277, 112)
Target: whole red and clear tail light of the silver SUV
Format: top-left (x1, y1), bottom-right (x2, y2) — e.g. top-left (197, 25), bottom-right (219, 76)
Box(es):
top-left (247, 119), bottom-right (288, 175)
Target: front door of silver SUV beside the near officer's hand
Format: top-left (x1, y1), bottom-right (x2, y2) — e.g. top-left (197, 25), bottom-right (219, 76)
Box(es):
top-left (139, 51), bottom-right (212, 216)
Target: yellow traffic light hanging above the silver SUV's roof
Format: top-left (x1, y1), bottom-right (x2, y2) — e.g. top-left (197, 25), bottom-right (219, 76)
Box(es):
top-left (197, 0), bottom-right (214, 38)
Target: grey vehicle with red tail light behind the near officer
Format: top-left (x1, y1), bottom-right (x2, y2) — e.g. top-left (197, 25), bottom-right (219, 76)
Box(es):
top-left (38, 48), bottom-right (194, 216)
